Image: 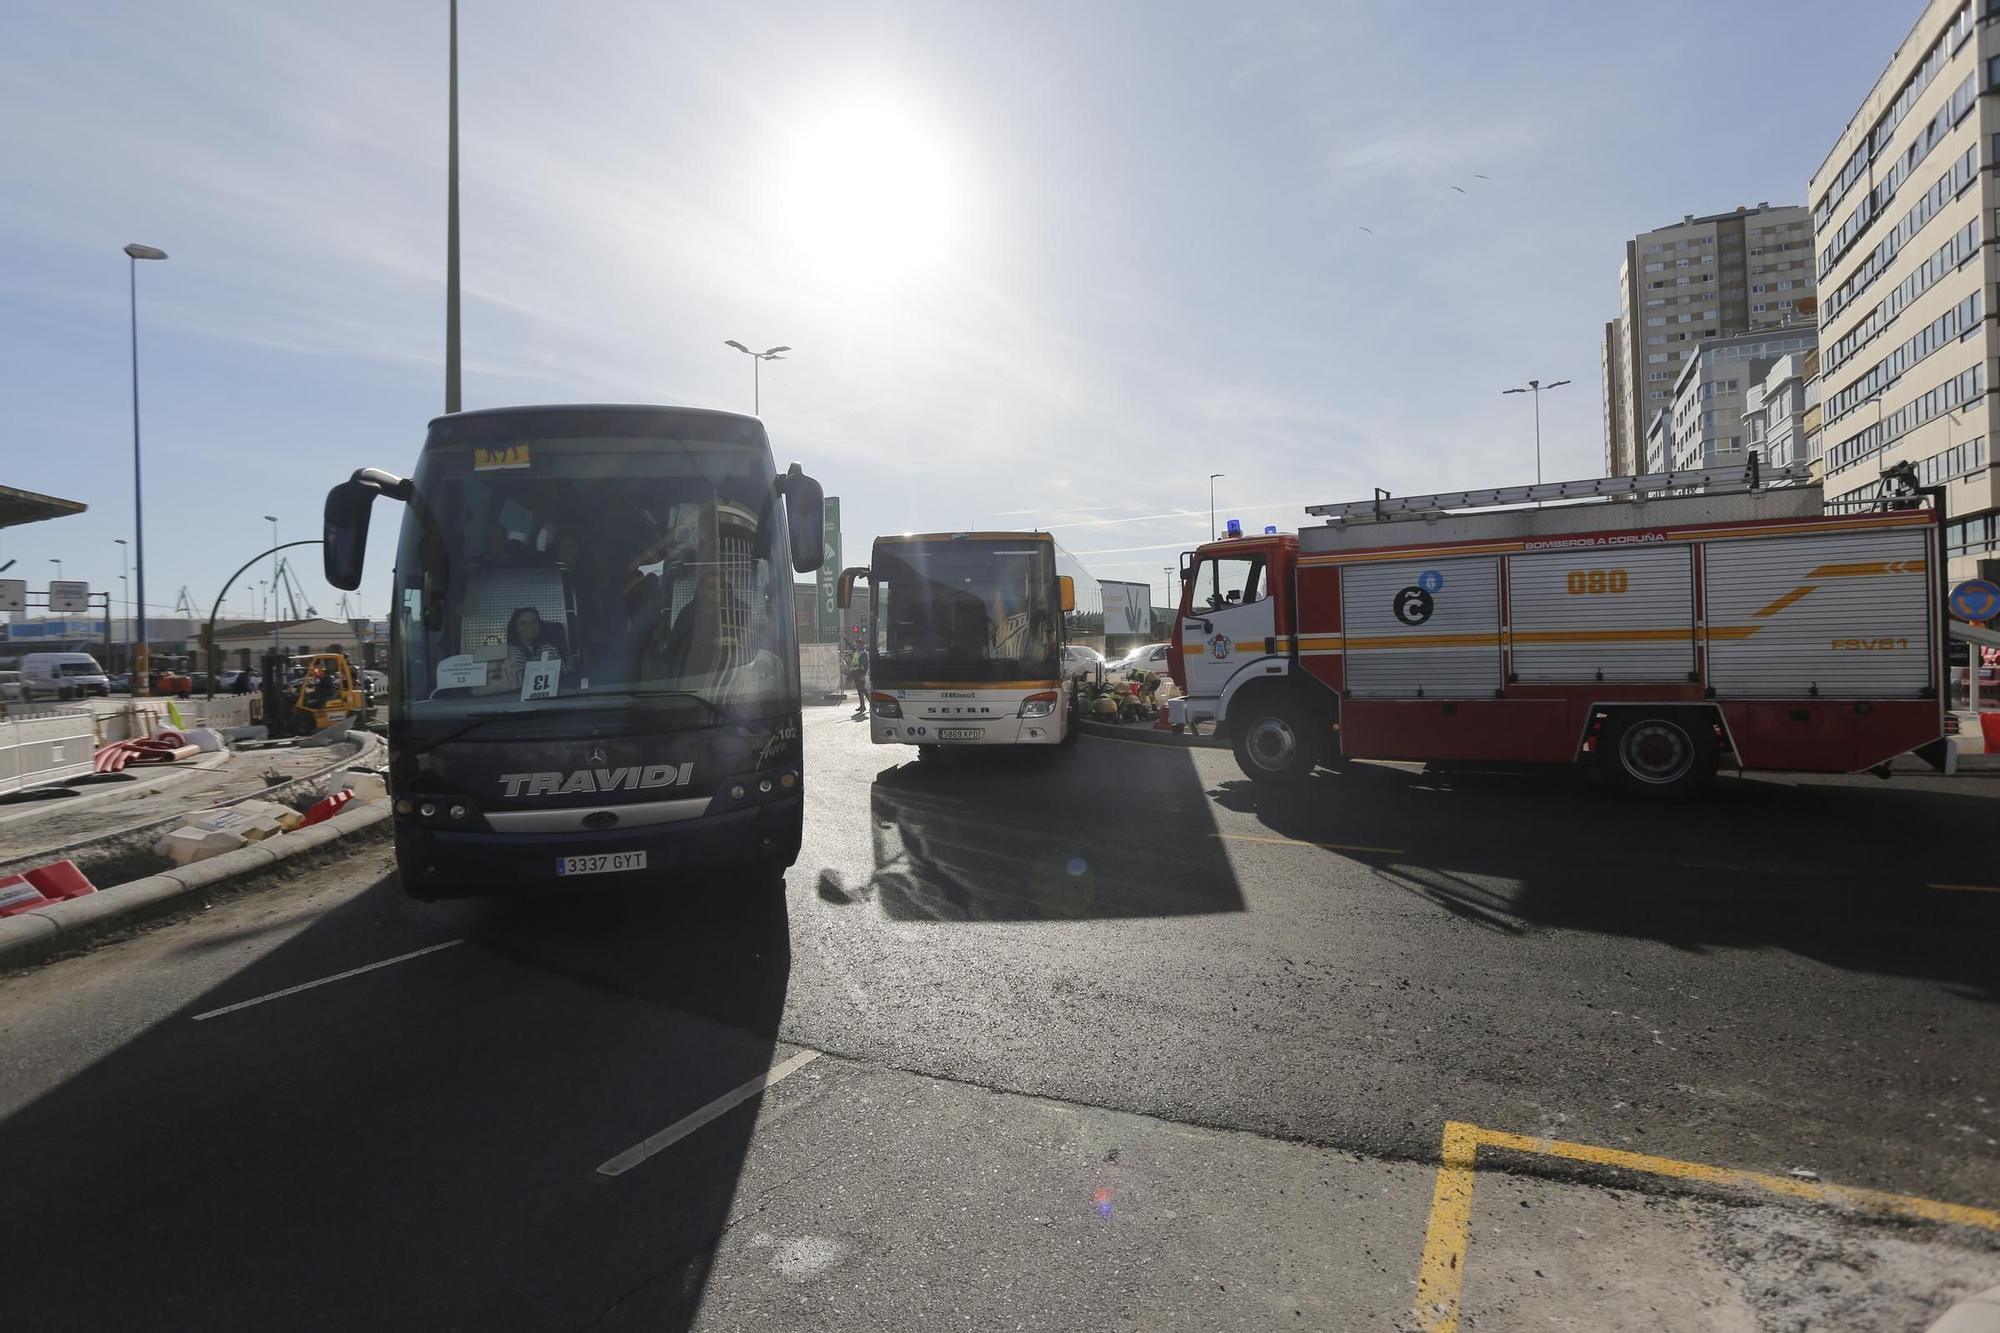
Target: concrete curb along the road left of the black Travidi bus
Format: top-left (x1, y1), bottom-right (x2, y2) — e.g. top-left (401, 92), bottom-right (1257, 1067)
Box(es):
top-left (0, 801), bottom-right (390, 971)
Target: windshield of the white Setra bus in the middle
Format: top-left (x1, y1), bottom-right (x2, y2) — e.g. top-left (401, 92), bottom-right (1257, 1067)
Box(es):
top-left (870, 538), bottom-right (1062, 685)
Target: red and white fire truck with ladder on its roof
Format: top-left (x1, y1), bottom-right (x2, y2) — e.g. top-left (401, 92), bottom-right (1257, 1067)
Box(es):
top-left (1170, 460), bottom-right (1950, 797)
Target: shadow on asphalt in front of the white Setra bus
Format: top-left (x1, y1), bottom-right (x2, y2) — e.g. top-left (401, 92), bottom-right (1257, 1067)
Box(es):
top-left (820, 747), bottom-right (1244, 921)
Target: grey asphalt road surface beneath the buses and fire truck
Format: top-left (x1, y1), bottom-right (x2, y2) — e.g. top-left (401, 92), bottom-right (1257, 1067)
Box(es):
top-left (0, 711), bottom-right (2000, 1329)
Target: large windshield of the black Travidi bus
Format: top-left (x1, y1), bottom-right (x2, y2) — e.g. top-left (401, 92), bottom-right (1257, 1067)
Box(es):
top-left (394, 418), bottom-right (798, 725)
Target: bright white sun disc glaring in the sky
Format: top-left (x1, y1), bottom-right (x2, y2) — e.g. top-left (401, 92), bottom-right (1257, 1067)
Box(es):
top-left (774, 100), bottom-right (954, 288)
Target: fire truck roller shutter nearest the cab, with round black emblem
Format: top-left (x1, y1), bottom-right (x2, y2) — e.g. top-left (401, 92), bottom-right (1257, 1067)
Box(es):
top-left (1340, 556), bottom-right (1500, 699)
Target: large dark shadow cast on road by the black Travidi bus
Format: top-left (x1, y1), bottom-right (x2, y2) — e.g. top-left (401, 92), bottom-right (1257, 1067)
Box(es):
top-left (0, 877), bottom-right (790, 1331)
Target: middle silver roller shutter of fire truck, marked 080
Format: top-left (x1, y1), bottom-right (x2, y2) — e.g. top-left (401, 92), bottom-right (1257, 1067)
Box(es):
top-left (1508, 544), bottom-right (1694, 685)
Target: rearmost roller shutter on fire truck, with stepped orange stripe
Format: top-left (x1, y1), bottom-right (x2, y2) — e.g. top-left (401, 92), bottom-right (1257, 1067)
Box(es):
top-left (1704, 528), bottom-right (1932, 699)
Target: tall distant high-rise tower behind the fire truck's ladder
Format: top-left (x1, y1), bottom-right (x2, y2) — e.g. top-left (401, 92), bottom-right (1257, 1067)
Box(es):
top-left (1602, 204), bottom-right (1814, 476)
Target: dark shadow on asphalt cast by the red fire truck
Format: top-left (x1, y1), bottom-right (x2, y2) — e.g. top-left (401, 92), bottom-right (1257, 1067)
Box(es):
top-left (1208, 763), bottom-right (2000, 1001)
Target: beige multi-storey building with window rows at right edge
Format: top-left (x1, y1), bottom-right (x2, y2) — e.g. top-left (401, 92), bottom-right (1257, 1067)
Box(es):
top-left (1808, 0), bottom-right (2000, 578)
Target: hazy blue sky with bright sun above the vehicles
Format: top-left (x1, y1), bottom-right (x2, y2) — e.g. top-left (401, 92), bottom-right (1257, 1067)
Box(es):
top-left (0, 0), bottom-right (1922, 616)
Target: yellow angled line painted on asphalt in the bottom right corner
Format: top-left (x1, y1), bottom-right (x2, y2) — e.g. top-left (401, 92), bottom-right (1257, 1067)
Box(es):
top-left (1412, 1112), bottom-right (2000, 1333)
